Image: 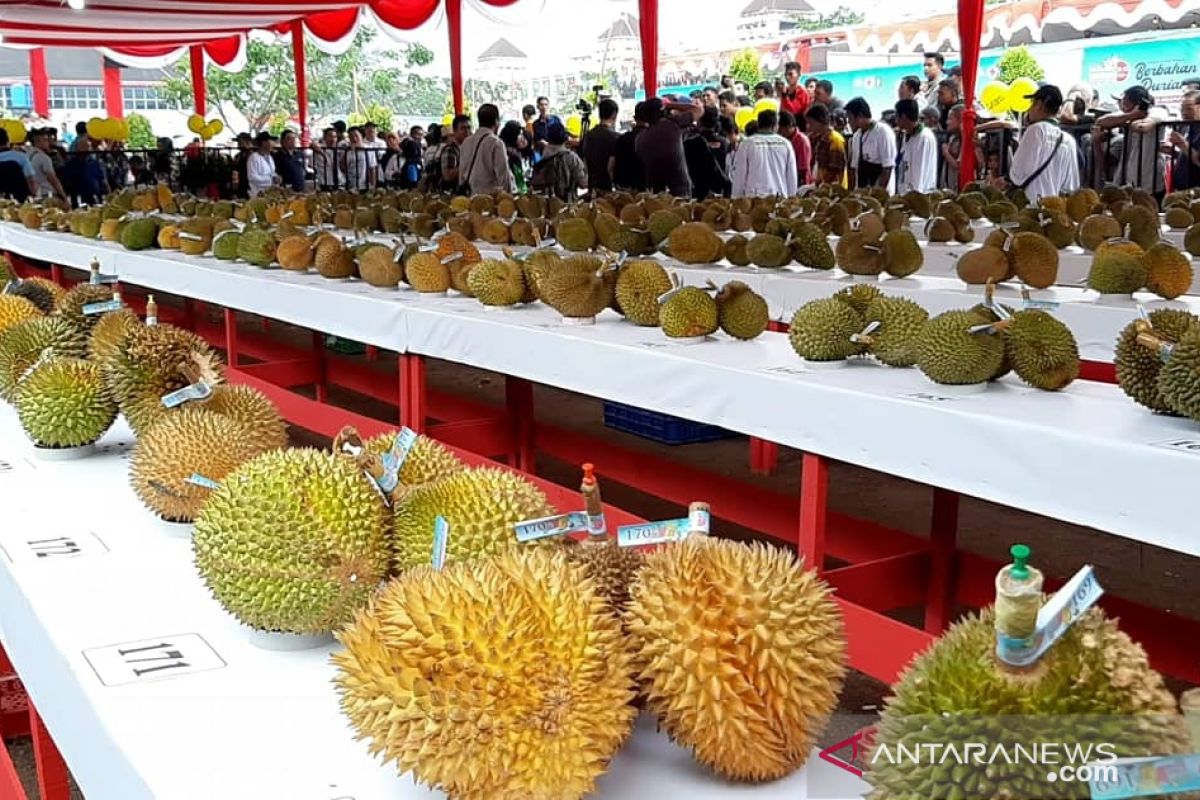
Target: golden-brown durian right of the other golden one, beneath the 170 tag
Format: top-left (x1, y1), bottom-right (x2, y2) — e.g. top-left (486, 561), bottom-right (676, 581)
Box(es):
top-left (625, 536), bottom-right (846, 781)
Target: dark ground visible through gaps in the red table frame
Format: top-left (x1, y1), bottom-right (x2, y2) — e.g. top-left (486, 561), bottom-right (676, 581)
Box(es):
top-left (5, 316), bottom-right (1200, 800)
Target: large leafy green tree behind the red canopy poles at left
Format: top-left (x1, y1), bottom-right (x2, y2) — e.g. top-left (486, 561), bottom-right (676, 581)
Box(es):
top-left (164, 28), bottom-right (445, 131)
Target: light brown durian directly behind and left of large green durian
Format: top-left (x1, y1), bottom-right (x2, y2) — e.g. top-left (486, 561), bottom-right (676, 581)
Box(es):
top-left (130, 409), bottom-right (274, 522)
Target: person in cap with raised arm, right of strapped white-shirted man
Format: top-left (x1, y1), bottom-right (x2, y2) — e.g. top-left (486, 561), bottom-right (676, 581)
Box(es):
top-left (1092, 84), bottom-right (1166, 200)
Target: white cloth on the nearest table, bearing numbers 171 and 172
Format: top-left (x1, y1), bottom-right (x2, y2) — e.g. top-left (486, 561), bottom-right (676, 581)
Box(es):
top-left (0, 407), bottom-right (865, 800)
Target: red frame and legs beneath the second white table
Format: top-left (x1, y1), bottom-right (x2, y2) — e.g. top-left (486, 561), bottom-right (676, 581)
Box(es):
top-left (0, 254), bottom-right (1200, 800)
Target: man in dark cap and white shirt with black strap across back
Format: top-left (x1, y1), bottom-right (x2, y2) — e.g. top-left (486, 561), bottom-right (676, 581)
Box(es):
top-left (996, 84), bottom-right (1079, 205)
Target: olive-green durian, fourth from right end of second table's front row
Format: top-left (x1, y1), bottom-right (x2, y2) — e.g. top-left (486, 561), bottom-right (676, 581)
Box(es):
top-left (917, 311), bottom-right (1004, 385)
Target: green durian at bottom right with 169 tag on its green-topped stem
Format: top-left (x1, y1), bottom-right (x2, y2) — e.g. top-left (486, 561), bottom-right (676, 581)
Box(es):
top-left (863, 608), bottom-right (1187, 800)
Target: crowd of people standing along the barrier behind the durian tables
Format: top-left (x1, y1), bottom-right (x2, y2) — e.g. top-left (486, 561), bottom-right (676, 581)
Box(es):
top-left (0, 53), bottom-right (1200, 204)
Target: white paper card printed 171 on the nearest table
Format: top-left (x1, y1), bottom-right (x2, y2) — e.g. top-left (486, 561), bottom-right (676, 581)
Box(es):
top-left (83, 633), bottom-right (226, 686)
